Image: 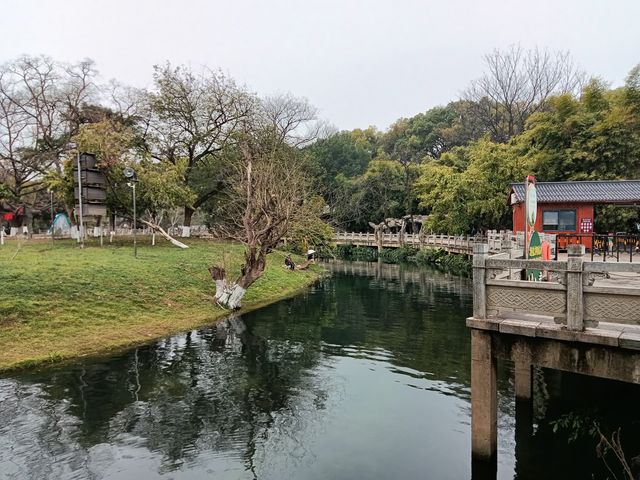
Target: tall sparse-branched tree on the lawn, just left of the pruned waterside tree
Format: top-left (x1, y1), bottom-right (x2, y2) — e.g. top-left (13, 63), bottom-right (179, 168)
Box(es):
top-left (146, 64), bottom-right (254, 236)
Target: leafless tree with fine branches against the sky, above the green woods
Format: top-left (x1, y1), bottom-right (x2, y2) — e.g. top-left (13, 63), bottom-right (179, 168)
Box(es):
top-left (463, 45), bottom-right (585, 142)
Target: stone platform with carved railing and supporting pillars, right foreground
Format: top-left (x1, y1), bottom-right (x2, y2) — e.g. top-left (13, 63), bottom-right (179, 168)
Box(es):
top-left (467, 244), bottom-right (640, 478)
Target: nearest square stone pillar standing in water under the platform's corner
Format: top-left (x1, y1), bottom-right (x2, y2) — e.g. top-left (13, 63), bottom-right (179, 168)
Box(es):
top-left (471, 329), bottom-right (498, 465)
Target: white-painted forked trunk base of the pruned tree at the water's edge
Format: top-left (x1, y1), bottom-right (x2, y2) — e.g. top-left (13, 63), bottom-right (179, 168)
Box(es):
top-left (209, 247), bottom-right (267, 310)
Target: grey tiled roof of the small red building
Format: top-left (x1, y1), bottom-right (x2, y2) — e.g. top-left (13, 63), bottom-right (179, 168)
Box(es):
top-left (511, 180), bottom-right (640, 204)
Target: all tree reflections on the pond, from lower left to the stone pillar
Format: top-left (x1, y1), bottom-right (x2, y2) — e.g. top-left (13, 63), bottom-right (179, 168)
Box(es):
top-left (0, 263), bottom-right (480, 478)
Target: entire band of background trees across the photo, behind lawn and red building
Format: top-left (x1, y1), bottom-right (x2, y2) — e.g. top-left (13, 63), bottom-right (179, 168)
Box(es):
top-left (0, 47), bottom-right (640, 238)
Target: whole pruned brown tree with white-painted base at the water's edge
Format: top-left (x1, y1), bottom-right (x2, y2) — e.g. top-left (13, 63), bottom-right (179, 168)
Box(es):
top-left (209, 127), bottom-right (319, 309)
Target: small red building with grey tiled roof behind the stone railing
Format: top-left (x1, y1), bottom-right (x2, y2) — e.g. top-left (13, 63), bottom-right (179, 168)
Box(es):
top-left (509, 180), bottom-right (640, 248)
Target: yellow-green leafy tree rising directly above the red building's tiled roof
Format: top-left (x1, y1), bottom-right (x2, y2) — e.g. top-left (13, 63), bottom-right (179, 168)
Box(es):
top-left (516, 74), bottom-right (640, 181)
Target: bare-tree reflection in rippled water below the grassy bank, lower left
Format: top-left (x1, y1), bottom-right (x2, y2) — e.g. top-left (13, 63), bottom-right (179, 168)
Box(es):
top-left (0, 317), bottom-right (326, 478)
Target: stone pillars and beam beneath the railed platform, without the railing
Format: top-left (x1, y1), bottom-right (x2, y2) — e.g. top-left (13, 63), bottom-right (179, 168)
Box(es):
top-left (467, 326), bottom-right (640, 472)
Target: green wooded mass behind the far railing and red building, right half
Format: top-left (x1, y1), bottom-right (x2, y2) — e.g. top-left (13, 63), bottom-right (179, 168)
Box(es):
top-left (309, 59), bottom-right (640, 234)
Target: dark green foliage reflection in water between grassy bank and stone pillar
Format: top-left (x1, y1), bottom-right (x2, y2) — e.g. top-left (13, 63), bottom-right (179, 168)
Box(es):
top-left (260, 262), bottom-right (472, 396)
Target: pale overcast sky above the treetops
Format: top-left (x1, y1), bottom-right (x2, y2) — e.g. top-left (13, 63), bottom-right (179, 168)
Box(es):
top-left (0, 0), bottom-right (640, 130)
